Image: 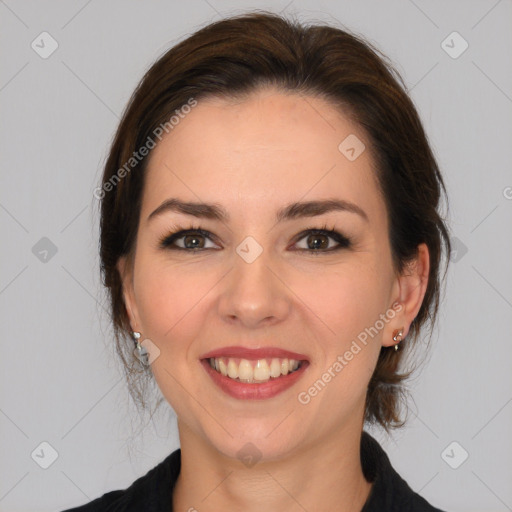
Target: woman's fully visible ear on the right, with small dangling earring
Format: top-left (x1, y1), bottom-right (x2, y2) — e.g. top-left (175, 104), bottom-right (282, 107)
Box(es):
top-left (382, 244), bottom-right (430, 347)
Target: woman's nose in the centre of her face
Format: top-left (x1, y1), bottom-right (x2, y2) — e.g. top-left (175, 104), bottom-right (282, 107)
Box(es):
top-left (219, 246), bottom-right (291, 329)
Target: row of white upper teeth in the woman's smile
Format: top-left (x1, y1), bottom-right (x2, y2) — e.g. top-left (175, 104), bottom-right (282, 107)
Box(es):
top-left (209, 357), bottom-right (300, 383)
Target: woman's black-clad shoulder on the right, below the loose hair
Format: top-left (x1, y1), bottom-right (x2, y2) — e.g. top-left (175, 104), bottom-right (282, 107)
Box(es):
top-left (361, 431), bottom-right (444, 512)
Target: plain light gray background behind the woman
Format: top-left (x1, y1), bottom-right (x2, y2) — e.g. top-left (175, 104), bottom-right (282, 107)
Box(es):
top-left (0, 0), bottom-right (512, 512)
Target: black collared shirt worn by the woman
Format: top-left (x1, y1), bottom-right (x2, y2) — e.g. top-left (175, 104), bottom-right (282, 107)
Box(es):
top-left (59, 431), bottom-right (443, 512)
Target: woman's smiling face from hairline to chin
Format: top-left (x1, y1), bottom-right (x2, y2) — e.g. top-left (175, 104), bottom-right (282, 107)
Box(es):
top-left (119, 90), bottom-right (425, 458)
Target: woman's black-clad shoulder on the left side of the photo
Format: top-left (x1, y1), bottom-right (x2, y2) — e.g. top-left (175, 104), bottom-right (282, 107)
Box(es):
top-left (62, 448), bottom-right (181, 512)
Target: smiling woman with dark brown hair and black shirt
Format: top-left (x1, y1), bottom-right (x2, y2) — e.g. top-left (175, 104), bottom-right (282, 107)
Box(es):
top-left (63, 9), bottom-right (450, 512)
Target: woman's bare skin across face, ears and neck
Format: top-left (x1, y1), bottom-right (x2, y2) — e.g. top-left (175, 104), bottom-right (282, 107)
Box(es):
top-left (118, 89), bottom-right (429, 511)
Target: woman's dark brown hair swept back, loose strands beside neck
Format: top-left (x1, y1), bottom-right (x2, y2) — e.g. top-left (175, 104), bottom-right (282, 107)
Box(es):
top-left (100, 11), bottom-right (450, 430)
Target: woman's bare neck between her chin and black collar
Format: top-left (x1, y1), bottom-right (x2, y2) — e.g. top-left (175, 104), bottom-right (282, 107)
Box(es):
top-left (173, 422), bottom-right (371, 512)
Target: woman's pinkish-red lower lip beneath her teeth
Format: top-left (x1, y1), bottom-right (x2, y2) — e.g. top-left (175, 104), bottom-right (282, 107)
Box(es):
top-left (201, 359), bottom-right (309, 400)
